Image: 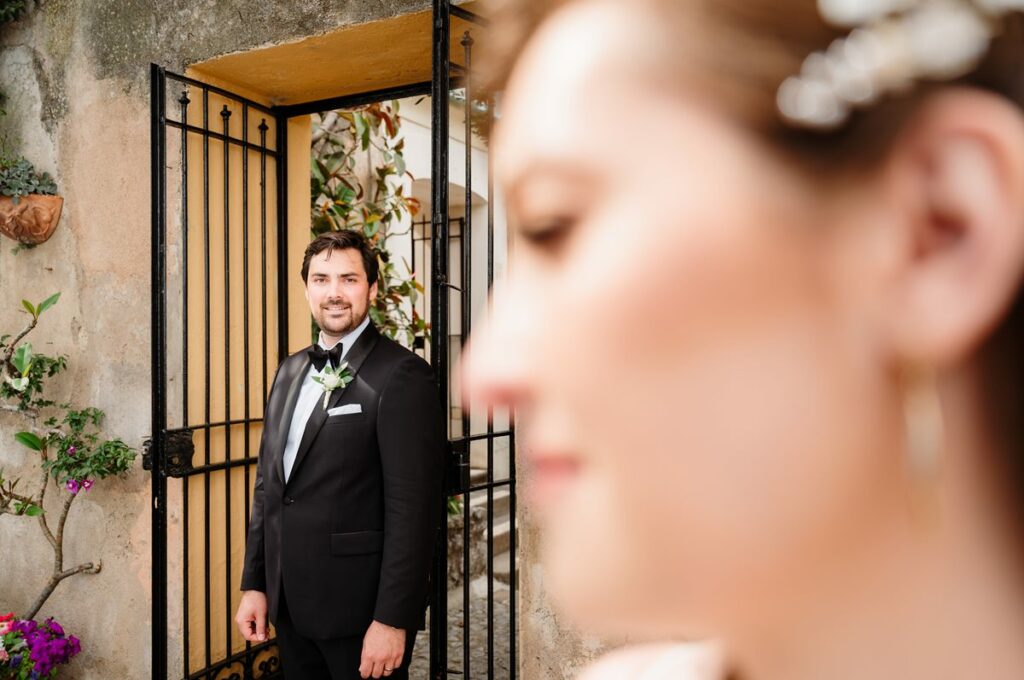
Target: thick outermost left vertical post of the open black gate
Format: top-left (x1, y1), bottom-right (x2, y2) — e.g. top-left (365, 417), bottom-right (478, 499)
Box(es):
top-left (150, 63), bottom-right (167, 678)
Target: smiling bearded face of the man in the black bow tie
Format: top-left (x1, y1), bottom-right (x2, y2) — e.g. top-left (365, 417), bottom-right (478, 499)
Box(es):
top-left (306, 248), bottom-right (377, 337)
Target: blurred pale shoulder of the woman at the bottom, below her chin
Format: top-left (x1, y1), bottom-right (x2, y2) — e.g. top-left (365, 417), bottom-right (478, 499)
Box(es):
top-left (580, 643), bottom-right (725, 680)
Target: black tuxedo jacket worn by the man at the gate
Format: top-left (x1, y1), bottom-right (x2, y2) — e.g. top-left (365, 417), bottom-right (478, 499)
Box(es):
top-left (242, 324), bottom-right (447, 639)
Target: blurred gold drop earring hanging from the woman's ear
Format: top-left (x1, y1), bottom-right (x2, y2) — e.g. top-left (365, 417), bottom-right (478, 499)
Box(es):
top-left (902, 367), bottom-right (945, 496)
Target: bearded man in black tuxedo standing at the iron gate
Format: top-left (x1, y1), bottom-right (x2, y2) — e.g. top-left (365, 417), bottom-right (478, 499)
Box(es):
top-left (236, 230), bottom-right (447, 680)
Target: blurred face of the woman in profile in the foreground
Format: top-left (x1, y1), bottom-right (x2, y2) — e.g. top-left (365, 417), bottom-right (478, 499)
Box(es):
top-left (467, 2), bottom-right (901, 634)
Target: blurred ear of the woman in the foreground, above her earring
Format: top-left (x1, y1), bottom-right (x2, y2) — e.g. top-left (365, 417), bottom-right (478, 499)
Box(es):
top-left (883, 88), bottom-right (1024, 368)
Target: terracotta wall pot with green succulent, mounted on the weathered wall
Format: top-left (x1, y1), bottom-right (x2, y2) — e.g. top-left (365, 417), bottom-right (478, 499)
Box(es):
top-left (0, 154), bottom-right (63, 246)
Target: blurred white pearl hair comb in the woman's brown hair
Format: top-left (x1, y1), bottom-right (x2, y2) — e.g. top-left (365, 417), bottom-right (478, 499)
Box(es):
top-left (776, 0), bottom-right (1024, 130)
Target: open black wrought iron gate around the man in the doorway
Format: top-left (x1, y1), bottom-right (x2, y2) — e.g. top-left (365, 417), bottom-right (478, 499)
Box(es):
top-left (145, 0), bottom-right (518, 680)
